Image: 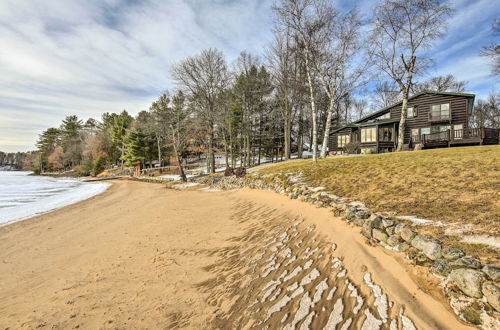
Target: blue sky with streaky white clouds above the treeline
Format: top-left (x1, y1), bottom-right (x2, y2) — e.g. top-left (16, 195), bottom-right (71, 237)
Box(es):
top-left (0, 0), bottom-right (500, 152)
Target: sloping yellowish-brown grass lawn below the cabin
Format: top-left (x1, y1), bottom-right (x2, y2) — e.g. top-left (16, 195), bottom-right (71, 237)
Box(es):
top-left (259, 145), bottom-right (500, 255)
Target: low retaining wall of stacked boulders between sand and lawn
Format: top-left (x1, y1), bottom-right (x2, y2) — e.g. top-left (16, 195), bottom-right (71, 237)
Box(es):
top-left (196, 175), bottom-right (500, 329)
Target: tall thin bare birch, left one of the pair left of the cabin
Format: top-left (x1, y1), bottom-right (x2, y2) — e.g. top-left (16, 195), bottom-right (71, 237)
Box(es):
top-left (273, 0), bottom-right (333, 161)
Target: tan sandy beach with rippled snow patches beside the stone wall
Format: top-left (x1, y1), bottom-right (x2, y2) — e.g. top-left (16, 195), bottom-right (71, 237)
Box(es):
top-left (0, 181), bottom-right (469, 329)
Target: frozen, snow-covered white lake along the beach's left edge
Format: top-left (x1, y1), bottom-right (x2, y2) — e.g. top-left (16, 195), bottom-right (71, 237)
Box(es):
top-left (0, 171), bottom-right (110, 226)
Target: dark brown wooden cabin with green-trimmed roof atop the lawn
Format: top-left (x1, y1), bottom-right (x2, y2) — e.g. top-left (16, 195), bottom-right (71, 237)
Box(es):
top-left (329, 91), bottom-right (500, 154)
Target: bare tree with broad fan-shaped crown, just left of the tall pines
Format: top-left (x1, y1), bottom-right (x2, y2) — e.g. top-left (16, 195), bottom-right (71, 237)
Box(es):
top-left (172, 48), bottom-right (230, 173)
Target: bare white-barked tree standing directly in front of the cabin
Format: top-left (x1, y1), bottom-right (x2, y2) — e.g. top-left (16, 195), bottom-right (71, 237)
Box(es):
top-left (371, 0), bottom-right (451, 151)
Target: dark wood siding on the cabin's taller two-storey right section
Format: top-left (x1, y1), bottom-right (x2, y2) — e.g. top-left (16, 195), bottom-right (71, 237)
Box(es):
top-left (390, 94), bottom-right (470, 143)
